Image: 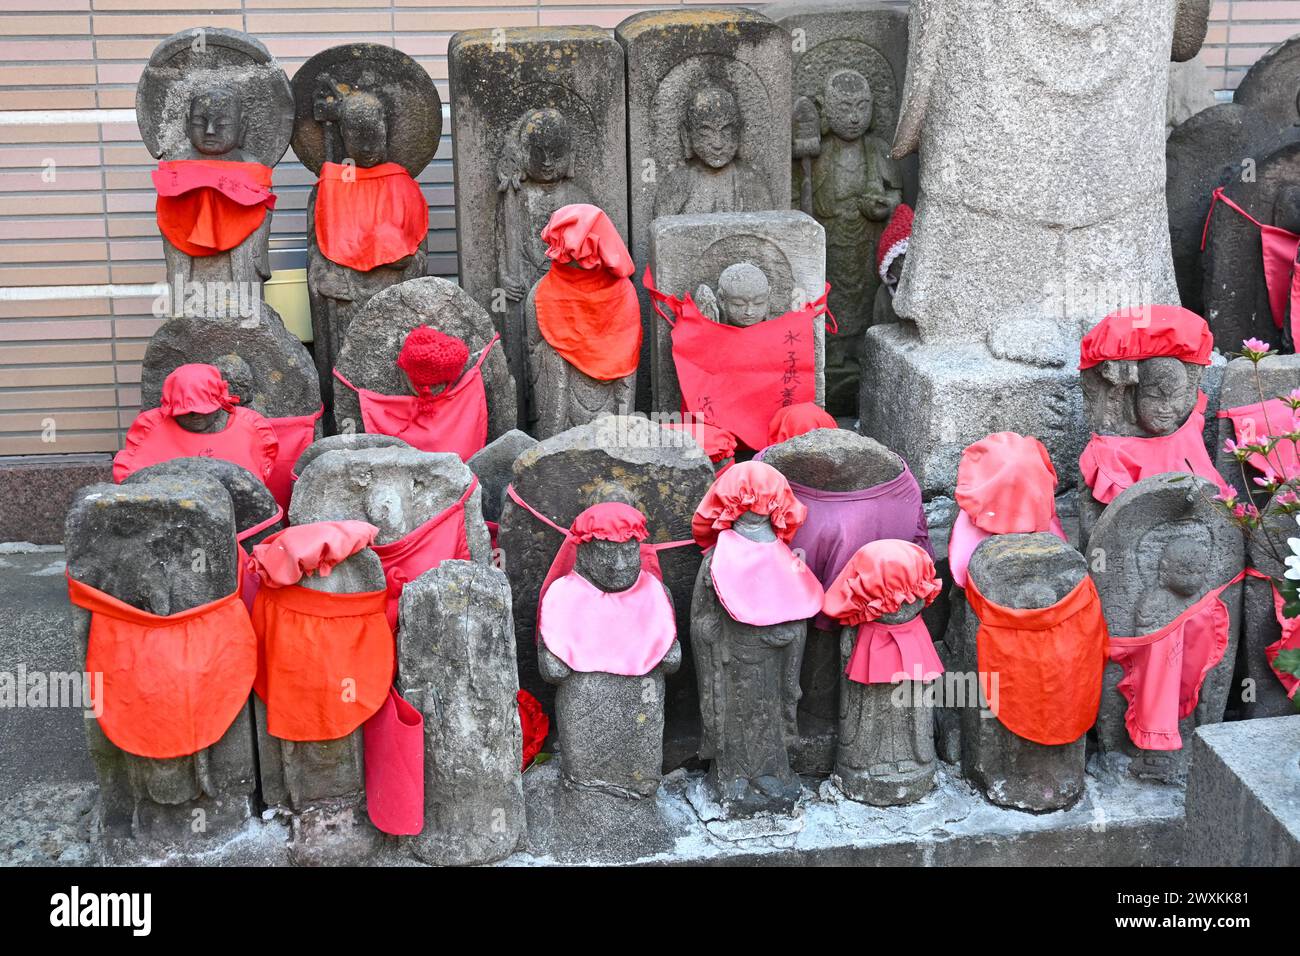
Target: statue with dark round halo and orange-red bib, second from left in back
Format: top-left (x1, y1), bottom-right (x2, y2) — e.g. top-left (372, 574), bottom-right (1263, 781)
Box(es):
top-left (294, 43), bottom-right (442, 395)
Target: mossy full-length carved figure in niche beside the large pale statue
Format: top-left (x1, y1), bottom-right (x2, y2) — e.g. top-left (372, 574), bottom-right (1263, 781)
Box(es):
top-left (807, 69), bottom-right (902, 414)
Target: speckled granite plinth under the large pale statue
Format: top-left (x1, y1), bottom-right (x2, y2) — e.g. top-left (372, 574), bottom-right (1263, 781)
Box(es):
top-left (858, 323), bottom-right (1087, 498)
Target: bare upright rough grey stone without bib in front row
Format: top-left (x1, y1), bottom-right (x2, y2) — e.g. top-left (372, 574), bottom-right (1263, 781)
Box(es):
top-left (398, 561), bottom-right (525, 866)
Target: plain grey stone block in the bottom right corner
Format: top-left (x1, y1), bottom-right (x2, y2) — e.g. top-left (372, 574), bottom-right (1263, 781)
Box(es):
top-left (1186, 715), bottom-right (1300, 866)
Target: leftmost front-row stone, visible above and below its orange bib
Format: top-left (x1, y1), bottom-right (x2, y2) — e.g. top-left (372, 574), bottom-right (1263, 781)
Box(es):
top-left (64, 475), bottom-right (257, 845)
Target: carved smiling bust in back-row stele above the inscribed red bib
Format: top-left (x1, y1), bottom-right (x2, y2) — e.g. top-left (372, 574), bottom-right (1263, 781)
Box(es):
top-left (654, 86), bottom-right (772, 217)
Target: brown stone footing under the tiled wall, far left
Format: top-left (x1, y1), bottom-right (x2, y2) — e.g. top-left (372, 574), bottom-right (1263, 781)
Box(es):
top-left (0, 455), bottom-right (113, 545)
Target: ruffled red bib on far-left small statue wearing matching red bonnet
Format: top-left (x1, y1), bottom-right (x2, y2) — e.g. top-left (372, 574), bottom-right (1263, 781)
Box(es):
top-left (113, 406), bottom-right (280, 483)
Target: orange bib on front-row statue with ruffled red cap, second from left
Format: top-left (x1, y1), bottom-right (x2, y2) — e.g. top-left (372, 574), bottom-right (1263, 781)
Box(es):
top-left (252, 584), bottom-right (397, 740)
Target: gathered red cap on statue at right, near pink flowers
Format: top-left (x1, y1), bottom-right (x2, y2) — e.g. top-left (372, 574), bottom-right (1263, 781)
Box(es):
top-left (1079, 306), bottom-right (1214, 369)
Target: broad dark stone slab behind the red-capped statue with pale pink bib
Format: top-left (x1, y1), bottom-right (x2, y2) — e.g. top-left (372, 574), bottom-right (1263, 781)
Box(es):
top-left (498, 415), bottom-right (714, 769)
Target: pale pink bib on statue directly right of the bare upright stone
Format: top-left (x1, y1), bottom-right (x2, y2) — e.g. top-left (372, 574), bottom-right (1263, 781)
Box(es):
top-left (537, 571), bottom-right (677, 678)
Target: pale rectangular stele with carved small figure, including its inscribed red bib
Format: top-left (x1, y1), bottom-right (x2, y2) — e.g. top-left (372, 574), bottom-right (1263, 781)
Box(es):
top-left (650, 209), bottom-right (827, 451)
